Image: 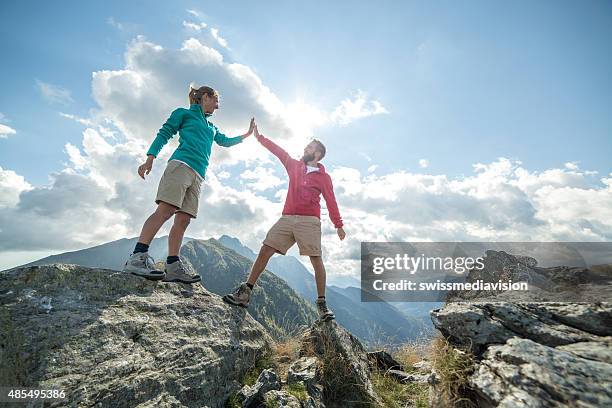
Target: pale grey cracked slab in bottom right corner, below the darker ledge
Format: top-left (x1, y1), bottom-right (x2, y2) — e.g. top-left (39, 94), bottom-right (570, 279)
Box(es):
top-left (470, 338), bottom-right (612, 407)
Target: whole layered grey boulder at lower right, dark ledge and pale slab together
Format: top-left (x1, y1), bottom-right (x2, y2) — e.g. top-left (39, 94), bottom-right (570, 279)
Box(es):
top-left (431, 301), bottom-right (612, 407)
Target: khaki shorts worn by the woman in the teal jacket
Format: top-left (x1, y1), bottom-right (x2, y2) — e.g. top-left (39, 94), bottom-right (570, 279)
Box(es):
top-left (155, 160), bottom-right (202, 218)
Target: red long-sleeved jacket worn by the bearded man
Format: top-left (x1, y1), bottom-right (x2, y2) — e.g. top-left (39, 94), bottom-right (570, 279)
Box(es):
top-left (257, 135), bottom-right (342, 228)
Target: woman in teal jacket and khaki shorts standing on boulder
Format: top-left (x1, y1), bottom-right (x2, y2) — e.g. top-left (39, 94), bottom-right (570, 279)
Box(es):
top-left (123, 86), bottom-right (255, 283)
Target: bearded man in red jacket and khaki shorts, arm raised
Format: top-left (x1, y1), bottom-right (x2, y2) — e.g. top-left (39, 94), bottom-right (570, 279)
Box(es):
top-left (223, 126), bottom-right (346, 321)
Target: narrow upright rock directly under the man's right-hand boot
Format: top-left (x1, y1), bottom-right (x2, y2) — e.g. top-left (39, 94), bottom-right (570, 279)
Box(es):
top-left (300, 320), bottom-right (382, 406)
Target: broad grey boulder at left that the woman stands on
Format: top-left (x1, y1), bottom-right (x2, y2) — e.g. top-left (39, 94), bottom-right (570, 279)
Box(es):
top-left (0, 264), bottom-right (272, 407)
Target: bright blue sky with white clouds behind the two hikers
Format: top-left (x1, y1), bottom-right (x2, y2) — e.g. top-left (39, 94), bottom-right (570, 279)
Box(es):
top-left (0, 1), bottom-right (612, 276)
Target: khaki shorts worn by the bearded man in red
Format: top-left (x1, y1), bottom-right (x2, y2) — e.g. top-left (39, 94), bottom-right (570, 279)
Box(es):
top-left (263, 215), bottom-right (321, 256)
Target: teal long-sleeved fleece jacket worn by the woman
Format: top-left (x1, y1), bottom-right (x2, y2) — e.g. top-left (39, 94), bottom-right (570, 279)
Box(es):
top-left (147, 104), bottom-right (242, 177)
